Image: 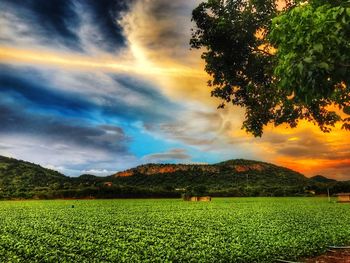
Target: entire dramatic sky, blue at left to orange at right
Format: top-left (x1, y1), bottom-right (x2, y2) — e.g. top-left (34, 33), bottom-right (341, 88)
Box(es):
top-left (0, 0), bottom-right (350, 180)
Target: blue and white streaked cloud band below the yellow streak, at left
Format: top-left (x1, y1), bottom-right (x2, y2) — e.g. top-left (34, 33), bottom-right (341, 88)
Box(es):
top-left (0, 65), bottom-right (177, 124)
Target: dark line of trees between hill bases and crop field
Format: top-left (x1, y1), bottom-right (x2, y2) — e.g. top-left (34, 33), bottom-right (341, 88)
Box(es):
top-left (0, 182), bottom-right (350, 199)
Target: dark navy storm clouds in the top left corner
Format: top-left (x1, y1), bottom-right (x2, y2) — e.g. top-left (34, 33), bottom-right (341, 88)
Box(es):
top-left (0, 0), bottom-right (130, 52)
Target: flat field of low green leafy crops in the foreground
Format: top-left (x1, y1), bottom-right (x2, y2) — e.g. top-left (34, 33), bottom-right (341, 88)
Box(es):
top-left (0, 198), bottom-right (350, 262)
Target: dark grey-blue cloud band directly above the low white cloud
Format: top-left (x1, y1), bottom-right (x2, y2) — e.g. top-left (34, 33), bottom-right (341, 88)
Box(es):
top-left (0, 103), bottom-right (131, 153)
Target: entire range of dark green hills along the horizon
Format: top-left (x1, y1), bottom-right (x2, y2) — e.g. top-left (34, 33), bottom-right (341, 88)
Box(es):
top-left (0, 156), bottom-right (350, 199)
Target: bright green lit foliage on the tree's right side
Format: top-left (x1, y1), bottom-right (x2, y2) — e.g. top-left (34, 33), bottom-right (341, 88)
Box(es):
top-left (269, 0), bottom-right (350, 131)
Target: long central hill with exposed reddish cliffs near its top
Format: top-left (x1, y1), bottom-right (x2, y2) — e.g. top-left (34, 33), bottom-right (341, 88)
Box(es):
top-left (112, 159), bottom-right (309, 196)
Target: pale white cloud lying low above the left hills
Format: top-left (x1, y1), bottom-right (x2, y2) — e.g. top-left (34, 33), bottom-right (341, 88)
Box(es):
top-left (0, 133), bottom-right (139, 176)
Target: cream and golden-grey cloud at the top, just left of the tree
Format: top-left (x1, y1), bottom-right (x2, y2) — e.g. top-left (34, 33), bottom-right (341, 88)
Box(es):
top-left (122, 0), bottom-right (200, 61)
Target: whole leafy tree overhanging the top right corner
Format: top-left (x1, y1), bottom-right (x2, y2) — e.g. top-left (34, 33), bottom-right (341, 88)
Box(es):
top-left (190, 0), bottom-right (350, 136)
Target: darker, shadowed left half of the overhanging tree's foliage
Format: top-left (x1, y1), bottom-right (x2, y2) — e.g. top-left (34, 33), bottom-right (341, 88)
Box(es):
top-left (190, 0), bottom-right (278, 136)
